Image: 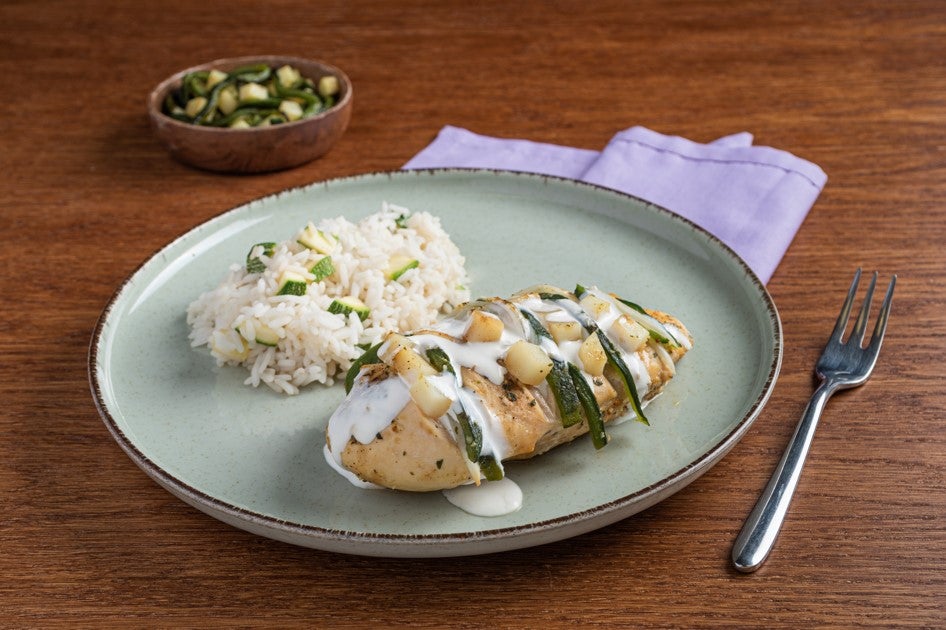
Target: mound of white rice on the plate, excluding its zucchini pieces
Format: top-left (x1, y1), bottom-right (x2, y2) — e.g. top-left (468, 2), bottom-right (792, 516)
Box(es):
top-left (187, 202), bottom-right (470, 394)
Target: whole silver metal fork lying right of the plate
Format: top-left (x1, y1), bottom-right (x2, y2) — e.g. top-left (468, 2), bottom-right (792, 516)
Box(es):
top-left (732, 269), bottom-right (897, 573)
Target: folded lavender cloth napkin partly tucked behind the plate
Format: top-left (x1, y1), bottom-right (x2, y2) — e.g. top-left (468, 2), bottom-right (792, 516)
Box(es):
top-left (404, 126), bottom-right (828, 283)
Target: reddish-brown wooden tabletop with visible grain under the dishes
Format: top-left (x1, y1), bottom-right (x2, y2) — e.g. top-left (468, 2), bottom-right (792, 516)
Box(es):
top-left (0, 0), bottom-right (946, 627)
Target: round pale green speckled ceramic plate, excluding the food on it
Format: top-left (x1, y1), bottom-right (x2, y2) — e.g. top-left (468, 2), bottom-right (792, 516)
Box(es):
top-left (89, 169), bottom-right (782, 557)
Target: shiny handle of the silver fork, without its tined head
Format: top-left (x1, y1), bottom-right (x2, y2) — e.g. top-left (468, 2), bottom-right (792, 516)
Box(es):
top-left (732, 379), bottom-right (837, 573)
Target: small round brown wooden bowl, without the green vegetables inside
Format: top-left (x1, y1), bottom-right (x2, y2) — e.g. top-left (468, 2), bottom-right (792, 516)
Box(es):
top-left (148, 56), bottom-right (352, 173)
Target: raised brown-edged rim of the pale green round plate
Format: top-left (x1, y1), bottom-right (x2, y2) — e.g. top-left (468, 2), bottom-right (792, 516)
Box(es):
top-left (87, 167), bottom-right (784, 557)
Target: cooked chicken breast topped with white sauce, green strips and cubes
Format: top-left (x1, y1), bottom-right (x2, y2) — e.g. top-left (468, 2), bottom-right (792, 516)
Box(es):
top-left (325, 286), bottom-right (693, 492)
